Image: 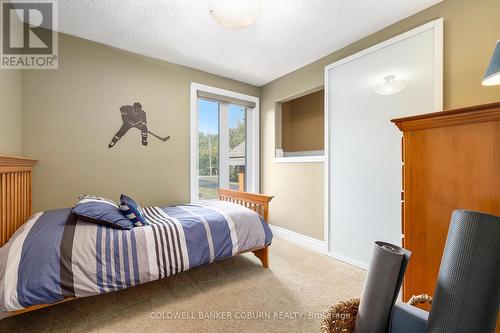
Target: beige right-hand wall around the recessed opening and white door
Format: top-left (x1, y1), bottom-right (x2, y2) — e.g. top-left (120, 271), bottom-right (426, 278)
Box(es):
top-left (261, 0), bottom-right (500, 239)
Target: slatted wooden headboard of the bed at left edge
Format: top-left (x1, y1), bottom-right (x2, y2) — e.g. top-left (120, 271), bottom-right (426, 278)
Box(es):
top-left (0, 155), bottom-right (37, 246)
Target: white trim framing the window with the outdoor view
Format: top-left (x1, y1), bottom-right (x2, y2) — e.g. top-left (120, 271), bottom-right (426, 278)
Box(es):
top-left (190, 82), bottom-right (260, 202)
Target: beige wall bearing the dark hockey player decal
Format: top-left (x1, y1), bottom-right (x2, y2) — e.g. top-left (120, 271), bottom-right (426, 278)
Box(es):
top-left (22, 34), bottom-right (260, 211)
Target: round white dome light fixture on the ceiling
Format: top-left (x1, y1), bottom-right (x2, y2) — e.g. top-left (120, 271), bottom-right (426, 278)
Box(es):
top-left (210, 0), bottom-right (262, 29)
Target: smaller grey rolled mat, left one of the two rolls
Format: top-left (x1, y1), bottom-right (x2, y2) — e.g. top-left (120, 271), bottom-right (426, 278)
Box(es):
top-left (354, 242), bottom-right (411, 333)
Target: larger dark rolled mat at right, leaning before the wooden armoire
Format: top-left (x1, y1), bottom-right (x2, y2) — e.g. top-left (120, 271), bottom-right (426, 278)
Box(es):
top-left (427, 210), bottom-right (500, 333)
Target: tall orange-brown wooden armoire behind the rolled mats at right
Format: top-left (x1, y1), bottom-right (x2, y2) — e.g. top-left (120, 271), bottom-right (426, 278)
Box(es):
top-left (392, 102), bottom-right (500, 301)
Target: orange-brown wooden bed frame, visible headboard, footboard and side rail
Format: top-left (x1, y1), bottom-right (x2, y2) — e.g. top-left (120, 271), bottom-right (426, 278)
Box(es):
top-left (0, 155), bottom-right (273, 319)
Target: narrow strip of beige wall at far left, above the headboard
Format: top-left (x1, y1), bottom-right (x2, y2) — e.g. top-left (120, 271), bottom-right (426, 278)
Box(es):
top-left (0, 69), bottom-right (21, 155)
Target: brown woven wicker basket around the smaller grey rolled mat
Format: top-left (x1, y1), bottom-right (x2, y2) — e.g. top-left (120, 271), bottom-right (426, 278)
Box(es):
top-left (321, 294), bottom-right (432, 333)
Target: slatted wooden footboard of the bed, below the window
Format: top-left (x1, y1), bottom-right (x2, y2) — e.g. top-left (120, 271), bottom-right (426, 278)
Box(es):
top-left (218, 189), bottom-right (274, 268)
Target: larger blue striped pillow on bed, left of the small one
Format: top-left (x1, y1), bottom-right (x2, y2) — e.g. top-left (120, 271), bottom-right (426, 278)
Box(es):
top-left (71, 195), bottom-right (134, 230)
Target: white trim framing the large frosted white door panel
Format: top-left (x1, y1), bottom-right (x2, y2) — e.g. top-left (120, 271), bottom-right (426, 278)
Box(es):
top-left (324, 18), bottom-right (443, 269)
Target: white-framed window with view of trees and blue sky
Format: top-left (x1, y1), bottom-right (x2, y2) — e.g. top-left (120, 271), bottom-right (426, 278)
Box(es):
top-left (191, 83), bottom-right (258, 202)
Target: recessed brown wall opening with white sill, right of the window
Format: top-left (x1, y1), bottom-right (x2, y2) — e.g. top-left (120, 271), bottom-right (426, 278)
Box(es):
top-left (275, 89), bottom-right (325, 162)
